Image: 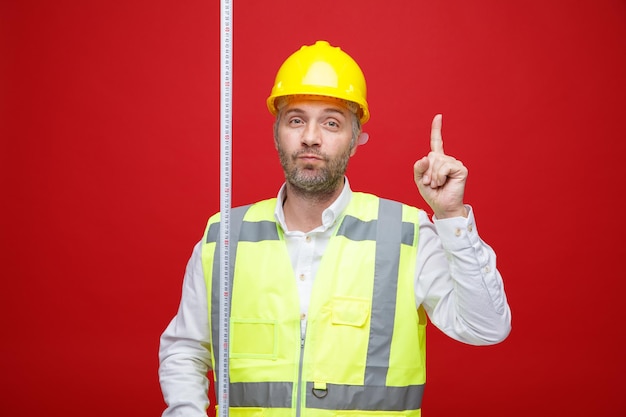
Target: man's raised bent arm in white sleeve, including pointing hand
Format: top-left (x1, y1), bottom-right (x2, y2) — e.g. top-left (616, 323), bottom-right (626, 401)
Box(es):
top-left (413, 114), bottom-right (511, 345)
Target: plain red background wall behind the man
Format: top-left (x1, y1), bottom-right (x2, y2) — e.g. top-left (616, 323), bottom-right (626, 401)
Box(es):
top-left (0, 0), bottom-right (626, 417)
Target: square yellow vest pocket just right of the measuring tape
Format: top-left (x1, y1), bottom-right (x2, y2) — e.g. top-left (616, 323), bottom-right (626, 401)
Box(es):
top-left (230, 317), bottom-right (278, 358)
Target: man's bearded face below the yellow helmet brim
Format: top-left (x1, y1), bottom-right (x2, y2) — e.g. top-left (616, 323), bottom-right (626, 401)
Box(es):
top-left (275, 98), bottom-right (356, 195)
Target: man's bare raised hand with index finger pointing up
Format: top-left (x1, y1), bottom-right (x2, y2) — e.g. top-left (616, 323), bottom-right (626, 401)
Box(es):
top-left (413, 114), bottom-right (467, 219)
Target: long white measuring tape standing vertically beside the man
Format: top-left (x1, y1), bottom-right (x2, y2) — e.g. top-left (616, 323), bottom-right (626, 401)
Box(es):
top-left (215, 0), bottom-right (233, 417)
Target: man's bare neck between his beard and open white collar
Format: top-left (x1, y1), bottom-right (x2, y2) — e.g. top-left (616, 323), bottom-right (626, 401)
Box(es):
top-left (283, 183), bottom-right (344, 233)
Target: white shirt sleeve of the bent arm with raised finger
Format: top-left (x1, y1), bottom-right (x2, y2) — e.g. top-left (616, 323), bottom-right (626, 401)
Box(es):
top-left (415, 206), bottom-right (511, 345)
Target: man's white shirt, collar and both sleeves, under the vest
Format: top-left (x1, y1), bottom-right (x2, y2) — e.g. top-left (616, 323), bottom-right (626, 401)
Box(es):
top-left (159, 178), bottom-right (511, 417)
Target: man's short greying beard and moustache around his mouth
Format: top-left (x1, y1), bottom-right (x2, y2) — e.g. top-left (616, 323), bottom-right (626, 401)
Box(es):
top-left (278, 144), bottom-right (351, 198)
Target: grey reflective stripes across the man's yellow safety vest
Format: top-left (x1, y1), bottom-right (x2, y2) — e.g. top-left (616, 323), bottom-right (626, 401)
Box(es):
top-left (201, 193), bottom-right (424, 411)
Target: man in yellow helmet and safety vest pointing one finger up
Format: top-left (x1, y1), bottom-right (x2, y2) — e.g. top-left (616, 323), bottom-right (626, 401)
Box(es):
top-left (159, 41), bottom-right (510, 417)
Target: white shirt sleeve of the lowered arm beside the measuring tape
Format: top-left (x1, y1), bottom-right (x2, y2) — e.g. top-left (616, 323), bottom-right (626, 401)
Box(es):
top-left (159, 242), bottom-right (211, 417)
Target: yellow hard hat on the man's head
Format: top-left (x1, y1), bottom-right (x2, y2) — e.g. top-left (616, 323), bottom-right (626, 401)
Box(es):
top-left (267, 41), bottom-right (370, 124)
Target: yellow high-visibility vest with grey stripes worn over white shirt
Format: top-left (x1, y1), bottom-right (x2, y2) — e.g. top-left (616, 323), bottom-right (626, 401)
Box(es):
top-left (202, 193), bottom-right (427, 417)
